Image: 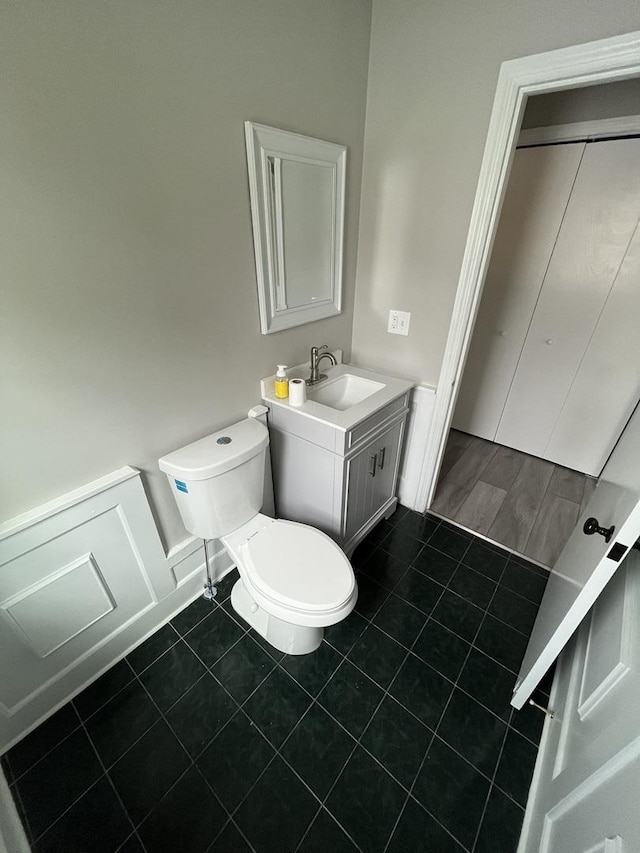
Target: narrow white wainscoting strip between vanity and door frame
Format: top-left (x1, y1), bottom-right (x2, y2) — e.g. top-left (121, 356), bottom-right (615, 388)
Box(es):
top-left (398, 385), bottom-right (436, 511)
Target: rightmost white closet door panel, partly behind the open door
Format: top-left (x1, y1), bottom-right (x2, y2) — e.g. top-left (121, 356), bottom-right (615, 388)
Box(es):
top-left (544, 220), bottom-right (640, 477)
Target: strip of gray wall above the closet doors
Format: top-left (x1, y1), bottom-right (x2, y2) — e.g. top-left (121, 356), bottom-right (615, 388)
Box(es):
top-left (522, 80), bottom-right (640, 127)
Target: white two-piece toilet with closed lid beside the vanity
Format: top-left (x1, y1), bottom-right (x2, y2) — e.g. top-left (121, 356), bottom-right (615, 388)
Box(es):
top-left (159, 418), bottom-right (358, 655)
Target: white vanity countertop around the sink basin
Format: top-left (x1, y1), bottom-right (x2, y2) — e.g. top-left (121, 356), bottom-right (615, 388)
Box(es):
top-left (260, 362), bottom-right (415, 431)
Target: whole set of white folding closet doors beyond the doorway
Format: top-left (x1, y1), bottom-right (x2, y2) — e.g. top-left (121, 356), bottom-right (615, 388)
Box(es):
top-left (453, 139), bottom-right (640, 476)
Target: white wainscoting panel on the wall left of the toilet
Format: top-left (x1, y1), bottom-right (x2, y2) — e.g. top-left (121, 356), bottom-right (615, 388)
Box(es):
top-left (0, 467), bottom-right (232, 753)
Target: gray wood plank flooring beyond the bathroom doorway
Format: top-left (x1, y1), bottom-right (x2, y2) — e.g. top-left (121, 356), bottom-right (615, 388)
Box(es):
top-left (431, 430), bottom-right (596, 567)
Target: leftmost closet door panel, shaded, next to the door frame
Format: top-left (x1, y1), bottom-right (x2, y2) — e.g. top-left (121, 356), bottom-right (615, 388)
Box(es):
top-left (453, 142), bottom-right (585, 440)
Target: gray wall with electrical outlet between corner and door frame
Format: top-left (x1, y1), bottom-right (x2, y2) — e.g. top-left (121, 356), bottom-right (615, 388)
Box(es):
top-left (352, 0), bottom-right (640, 383)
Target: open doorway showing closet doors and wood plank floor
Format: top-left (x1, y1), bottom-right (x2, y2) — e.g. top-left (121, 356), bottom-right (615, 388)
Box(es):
top-left (431, 96), bottom-right (640, 567)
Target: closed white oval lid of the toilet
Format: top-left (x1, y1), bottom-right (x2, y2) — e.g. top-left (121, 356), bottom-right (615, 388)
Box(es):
top-left (243, 521), bottom-right (355, 610)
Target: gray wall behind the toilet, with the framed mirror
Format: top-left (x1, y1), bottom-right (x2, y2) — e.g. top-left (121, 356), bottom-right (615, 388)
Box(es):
top-left (0, 0), bottom-right (370, 546)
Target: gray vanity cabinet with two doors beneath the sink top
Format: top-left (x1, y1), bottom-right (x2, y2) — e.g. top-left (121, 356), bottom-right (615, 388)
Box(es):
top-left (265, 392), bottom-right (410, 554)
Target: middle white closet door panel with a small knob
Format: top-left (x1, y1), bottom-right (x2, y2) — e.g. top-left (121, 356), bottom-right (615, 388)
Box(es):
top-left (495, 139), bottom-right (640, 465)
